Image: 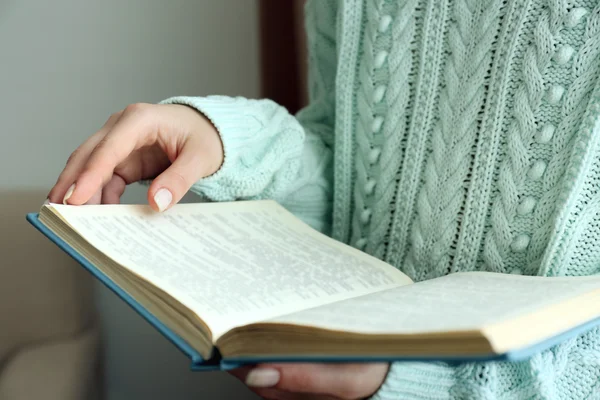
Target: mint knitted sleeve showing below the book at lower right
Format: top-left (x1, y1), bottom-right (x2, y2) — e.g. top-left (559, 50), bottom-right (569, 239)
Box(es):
top-left (371, 328), bottom-right (600, 400)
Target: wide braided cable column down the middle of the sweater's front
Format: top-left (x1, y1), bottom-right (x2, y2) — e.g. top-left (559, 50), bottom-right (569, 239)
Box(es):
top-left (408, 0), bottom-right (502, 280)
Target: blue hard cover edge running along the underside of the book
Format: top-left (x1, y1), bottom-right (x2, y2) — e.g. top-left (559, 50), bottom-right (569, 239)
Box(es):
top-left (26, 213), bottom-right (600, 371)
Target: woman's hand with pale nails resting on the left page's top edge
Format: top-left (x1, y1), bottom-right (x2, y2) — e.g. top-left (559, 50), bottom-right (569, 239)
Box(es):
top-left (48, 104), bottom-right (223, 211)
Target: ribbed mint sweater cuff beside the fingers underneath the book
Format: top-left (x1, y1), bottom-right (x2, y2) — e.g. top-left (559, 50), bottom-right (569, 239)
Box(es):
top-left (371, 362), bottom-right (455, 400)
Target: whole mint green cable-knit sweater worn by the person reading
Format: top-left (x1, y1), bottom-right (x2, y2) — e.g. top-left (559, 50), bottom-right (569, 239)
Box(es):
top-left (165, 0), bottom-right (600, 399)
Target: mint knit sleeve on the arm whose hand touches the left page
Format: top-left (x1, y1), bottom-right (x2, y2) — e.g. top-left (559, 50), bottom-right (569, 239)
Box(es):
top-left (162, 0), bottom-right (337, 233)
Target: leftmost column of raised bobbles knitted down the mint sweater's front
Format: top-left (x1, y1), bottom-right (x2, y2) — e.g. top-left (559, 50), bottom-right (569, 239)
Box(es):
top-left (352, 0), bottom-right (417, 258)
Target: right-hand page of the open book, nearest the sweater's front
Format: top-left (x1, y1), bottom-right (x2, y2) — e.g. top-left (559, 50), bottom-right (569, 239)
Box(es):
top-left (270, 272), bottom-right (600, 334)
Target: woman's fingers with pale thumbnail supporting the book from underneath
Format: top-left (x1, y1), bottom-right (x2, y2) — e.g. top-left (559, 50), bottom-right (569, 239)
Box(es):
top-left (231, 364), bottom-right (389, 400)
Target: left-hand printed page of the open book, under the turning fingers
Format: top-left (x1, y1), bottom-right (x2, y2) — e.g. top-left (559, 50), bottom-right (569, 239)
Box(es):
top-left (52, 201), bottom-right (411, 338)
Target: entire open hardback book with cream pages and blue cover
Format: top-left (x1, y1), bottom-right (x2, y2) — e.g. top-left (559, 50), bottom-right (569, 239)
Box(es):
top-left (28, 201), bottom-right (600, 369)
